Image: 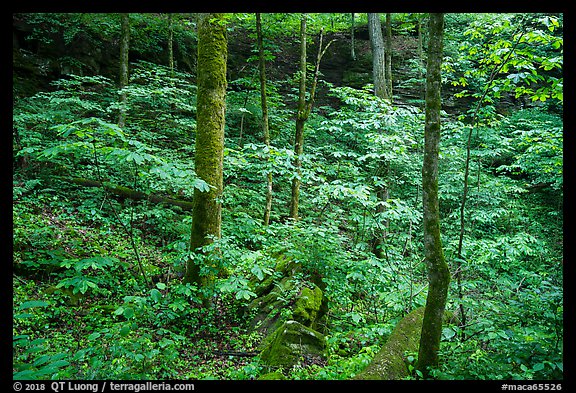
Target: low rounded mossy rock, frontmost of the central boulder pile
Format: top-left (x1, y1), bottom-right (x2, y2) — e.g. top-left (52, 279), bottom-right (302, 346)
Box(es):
top-left (260, 320), bottom-right (326, 367)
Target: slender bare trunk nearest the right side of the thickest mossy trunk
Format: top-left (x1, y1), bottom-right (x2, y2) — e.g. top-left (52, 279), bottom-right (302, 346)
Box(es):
top-left (256, 13), bottom-right (272, 225)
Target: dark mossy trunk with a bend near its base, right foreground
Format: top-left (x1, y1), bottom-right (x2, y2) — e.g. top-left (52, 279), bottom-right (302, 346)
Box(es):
top-left (417, 13), bottom-right (450, 375)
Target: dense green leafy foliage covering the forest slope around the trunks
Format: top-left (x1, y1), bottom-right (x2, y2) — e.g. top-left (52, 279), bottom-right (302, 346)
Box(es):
top-left (12, 14), bottom-right (564, 380)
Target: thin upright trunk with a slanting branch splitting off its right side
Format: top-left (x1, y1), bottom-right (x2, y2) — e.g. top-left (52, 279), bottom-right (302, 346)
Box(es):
top-left (290, 14), bottom-right (307, 220)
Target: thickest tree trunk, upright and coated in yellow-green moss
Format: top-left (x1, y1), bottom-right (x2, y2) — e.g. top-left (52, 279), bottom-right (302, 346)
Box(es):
top-left (184, 14), bottom-right (228, 294)
